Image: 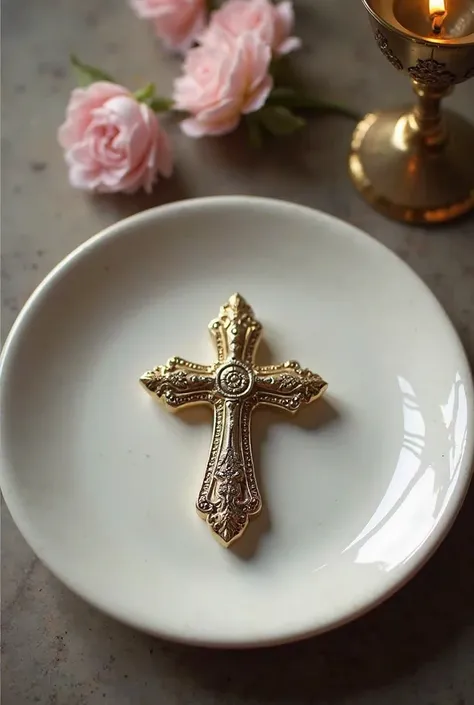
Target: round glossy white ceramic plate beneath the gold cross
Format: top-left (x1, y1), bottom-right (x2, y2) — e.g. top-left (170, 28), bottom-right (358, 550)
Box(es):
top-left (0, 197), bottom-right (474, 646)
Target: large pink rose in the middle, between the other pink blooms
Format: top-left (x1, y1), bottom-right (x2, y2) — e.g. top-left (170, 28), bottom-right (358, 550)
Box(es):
top-left (173, 30), bottom-right (273, 137)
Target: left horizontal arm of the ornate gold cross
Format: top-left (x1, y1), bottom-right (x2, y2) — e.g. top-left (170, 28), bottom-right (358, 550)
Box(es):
top-left (140, 357), bottom-right (215, 408)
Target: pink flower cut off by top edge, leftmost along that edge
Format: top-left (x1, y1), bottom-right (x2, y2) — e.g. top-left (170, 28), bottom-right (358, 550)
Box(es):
top-left (130, 0), bottom-right (206, 53)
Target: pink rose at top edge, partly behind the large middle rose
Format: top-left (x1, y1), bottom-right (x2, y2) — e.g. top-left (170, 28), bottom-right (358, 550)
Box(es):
top-left (200, 0), bottom-right (301, 55)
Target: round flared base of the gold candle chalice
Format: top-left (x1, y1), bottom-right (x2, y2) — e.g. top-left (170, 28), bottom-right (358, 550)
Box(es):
top-left (349, 109), bottom-right (474, 223)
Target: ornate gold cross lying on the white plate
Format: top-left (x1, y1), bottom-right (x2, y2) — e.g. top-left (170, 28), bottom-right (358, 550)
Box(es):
top-left (141, 294), bottom-right (327, 547)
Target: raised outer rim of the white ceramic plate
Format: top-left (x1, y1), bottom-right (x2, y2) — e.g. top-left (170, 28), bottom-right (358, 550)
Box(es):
top-left (0, 195), bottom-right (474, 649)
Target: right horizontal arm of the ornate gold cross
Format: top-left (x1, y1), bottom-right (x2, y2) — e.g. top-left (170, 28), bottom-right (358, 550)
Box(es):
top-left (255, 360), bottom-right (327, 412)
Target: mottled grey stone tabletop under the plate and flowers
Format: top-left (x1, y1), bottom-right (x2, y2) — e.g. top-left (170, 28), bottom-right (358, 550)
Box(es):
top-left (2, 0), bottom-right (474, 705)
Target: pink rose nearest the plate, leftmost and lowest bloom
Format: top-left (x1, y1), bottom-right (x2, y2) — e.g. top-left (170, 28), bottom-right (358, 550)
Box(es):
top-left (58, 81), bottom-right (173, 193)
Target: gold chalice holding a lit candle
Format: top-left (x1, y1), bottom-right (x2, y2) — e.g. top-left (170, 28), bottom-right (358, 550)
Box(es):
top-left (349, 0), bottom-right (474, 223)
